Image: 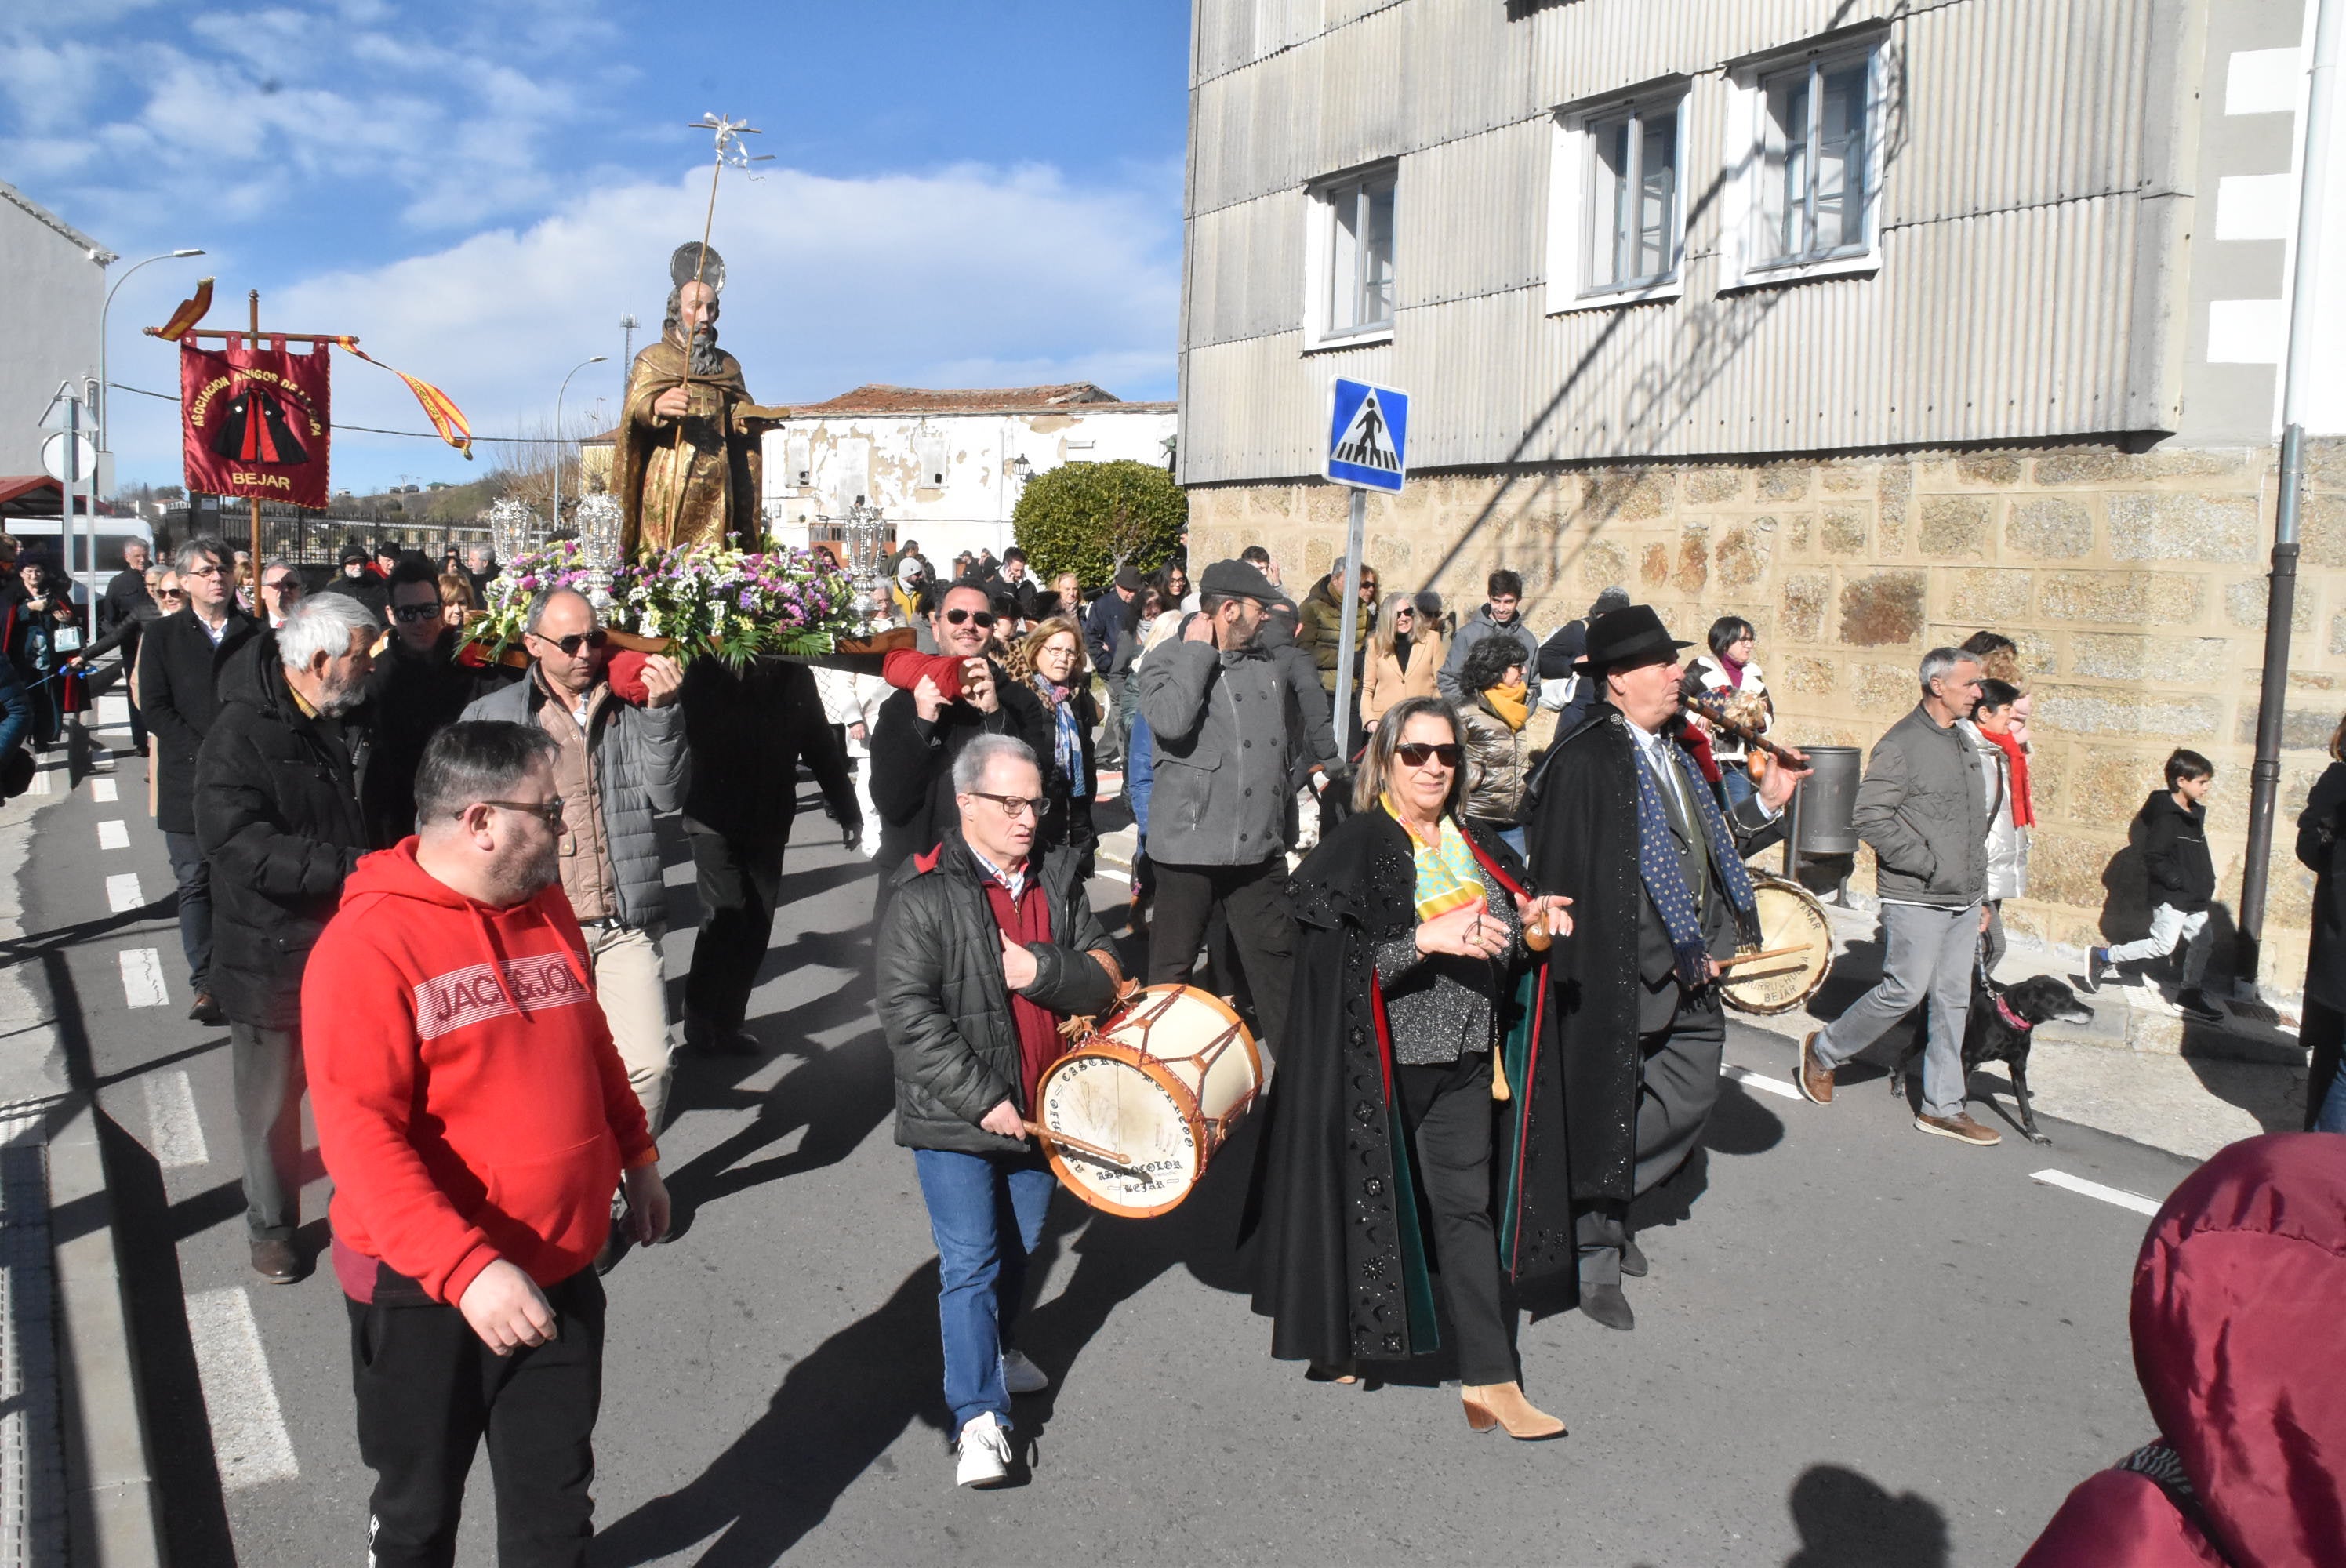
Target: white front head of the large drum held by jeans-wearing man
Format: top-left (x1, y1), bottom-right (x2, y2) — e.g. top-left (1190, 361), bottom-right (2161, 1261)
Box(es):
top-left (1034, 1044), bottom-right (1208, 1218)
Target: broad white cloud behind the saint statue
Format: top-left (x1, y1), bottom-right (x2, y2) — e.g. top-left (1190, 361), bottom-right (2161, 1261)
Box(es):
top-left (100, 165), bottom-right (1180, 486)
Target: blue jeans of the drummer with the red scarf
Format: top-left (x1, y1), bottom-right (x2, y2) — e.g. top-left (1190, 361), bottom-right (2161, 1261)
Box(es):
top-left (913, 1148), bottom-right (1058, 1432)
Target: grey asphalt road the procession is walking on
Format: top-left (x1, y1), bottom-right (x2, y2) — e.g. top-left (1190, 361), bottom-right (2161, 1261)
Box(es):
top-left (24, 756), bottom-right (2189, 1568)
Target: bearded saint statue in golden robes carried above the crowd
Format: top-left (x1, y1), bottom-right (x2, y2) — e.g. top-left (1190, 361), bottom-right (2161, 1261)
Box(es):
top-left (612, 244), bottom-right (783, 561)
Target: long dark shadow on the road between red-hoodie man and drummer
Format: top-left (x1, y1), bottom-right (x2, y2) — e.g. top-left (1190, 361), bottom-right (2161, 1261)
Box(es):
top-left (586, 1261), bottom-right (950, 1568)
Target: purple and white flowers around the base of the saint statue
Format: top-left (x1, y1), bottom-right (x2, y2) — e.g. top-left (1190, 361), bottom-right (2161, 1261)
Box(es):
top-left (471, 538), bottom-right (856, 666)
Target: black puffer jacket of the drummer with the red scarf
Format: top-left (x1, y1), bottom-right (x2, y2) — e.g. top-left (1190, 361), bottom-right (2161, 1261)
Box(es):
top-left (873, 831), bottom-right (1117, 1155)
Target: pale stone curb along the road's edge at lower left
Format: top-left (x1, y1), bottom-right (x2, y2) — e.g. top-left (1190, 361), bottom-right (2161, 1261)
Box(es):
top-left (49, 1091), bottom-right (166, 1568)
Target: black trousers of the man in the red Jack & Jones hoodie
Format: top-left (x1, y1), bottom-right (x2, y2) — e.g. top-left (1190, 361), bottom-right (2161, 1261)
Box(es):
top-left (345, 1268), bottom-right (603, 1568)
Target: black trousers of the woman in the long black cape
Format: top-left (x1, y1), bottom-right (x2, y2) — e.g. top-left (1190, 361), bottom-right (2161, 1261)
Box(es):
top-left (1393, 1051), bottom-right (1516, 1382)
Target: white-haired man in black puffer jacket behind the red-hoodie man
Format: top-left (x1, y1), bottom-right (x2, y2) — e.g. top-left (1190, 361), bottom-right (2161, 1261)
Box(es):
top-left (194, 593), bottom-right (383, 1284)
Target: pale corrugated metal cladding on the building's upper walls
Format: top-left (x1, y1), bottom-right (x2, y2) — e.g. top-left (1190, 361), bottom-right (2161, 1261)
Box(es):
top-left (1180, 0), bottom-right (2189, 484)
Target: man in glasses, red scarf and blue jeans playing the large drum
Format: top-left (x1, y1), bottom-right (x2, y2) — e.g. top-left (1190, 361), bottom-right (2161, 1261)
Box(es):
top-left (873, 735), bottom-right (1124, 1486)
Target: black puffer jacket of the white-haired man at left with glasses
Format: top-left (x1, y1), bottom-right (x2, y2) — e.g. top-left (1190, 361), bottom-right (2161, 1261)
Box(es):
top-left (194, 631), bottom-right (366, 1028)
